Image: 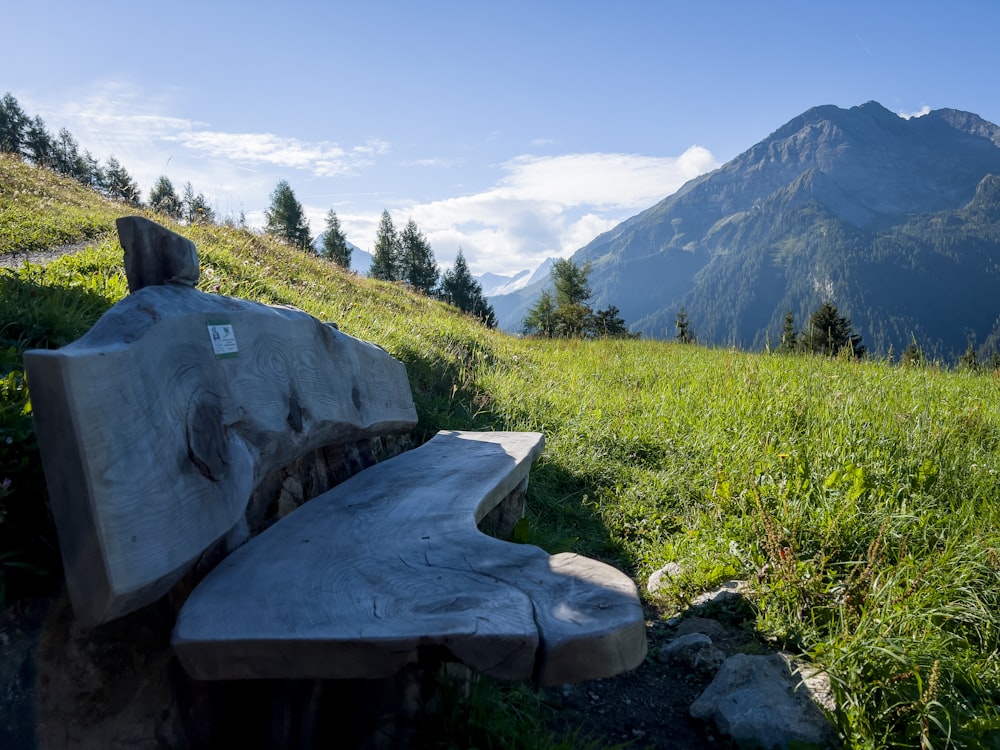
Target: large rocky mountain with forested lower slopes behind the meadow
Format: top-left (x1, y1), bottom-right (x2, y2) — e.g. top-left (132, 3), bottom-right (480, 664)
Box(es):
top-left (490, 102), bottom-right (1000, 357)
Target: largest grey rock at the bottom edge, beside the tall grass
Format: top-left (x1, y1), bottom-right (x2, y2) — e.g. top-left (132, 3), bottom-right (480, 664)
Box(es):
top-left (690, 654), bottom-right (836, 750)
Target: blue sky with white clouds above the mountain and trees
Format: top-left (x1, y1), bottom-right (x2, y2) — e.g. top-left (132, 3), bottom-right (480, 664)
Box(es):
top-left (7, 0), bottom-right (1000, 274)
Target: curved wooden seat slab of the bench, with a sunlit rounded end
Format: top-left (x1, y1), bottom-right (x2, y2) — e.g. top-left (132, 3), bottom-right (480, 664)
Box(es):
top-left (173, 432), bottom-right (646, 684)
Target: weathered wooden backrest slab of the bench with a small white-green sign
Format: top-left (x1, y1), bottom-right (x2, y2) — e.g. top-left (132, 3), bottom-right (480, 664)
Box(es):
top-left (24, 285), bottom-right (416, 624)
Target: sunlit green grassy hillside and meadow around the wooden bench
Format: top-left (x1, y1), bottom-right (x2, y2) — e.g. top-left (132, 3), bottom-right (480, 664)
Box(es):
top-left (0, 159), bottom-right (1000, 747)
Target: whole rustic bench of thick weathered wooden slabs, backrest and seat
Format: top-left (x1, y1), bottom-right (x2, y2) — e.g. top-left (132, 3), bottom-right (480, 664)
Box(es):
top-left (24, 217), bottom-right (646, 684)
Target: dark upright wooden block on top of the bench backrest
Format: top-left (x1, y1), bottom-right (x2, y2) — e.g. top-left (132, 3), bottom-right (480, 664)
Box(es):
top-left (115, 216), bottom-right (201, 292)
